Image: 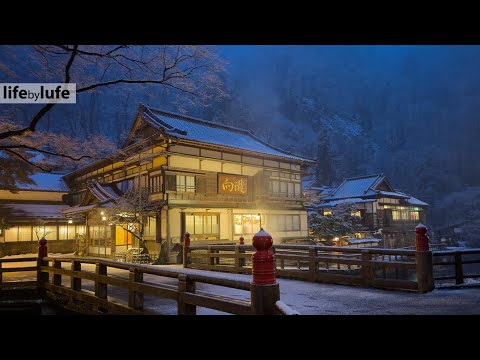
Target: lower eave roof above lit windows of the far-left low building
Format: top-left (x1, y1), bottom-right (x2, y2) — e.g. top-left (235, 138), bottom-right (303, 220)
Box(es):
top-left (0, 204), bottom-right (68, 220)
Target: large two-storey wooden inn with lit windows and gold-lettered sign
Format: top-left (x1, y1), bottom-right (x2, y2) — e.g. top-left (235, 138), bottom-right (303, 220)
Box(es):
top-left (62, 105), bottom-right (314, 257)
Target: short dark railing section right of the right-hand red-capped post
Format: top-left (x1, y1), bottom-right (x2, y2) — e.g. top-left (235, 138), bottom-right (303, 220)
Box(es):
top-left (433, 249), bottom-right (480, 285)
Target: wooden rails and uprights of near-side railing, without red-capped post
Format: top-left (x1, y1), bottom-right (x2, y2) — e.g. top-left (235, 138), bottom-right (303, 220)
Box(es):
top-left (36, 256), bottom-right (278, 315)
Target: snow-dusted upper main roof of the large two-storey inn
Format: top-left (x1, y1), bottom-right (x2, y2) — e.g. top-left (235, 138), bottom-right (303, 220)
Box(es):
top-left (140, 106), bottom-right (313, 162)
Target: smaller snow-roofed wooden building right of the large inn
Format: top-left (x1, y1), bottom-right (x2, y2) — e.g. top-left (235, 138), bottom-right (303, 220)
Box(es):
top-left (315, 174), bottom-right (428, 248)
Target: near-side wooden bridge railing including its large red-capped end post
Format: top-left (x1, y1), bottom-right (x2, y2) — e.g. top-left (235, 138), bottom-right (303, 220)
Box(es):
top-left (34, 234), bottom-right (298, 315)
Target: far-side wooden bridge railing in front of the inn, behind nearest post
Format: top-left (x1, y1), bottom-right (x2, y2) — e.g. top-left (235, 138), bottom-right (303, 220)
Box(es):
top-left (185, 244), bottom-right (417, 290)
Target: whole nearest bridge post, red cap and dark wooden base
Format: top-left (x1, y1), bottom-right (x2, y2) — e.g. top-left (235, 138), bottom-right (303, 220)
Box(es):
top-left (250, 228), bottom-right (280, 315)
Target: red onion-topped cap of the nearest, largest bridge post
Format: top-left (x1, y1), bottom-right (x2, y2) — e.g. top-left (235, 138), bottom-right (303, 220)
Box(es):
top-left (252, 228), bottom-right (275, 285)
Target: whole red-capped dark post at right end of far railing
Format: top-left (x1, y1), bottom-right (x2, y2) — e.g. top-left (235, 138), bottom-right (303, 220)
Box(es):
top-left (415, 223), bottom-right (435, 293)
